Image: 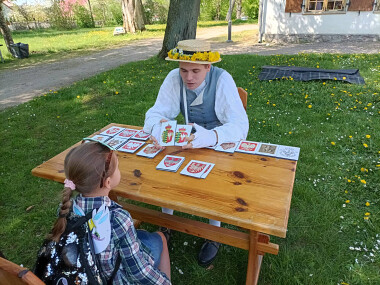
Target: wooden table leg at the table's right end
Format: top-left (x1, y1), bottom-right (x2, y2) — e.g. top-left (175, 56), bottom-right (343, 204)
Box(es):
top-left (246, 231), bottom-right (263, 285)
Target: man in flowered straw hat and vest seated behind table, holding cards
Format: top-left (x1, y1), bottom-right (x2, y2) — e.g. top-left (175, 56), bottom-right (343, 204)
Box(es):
top-left (144, 39), bottom-right (249, 266)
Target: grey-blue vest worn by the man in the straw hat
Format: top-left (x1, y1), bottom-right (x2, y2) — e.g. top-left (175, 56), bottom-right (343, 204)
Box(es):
top-left (178, 65), bottom-right (224, 130)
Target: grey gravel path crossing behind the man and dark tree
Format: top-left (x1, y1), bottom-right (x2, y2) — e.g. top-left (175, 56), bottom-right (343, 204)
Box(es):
top-left (0, 24), bottom-right (380, 109)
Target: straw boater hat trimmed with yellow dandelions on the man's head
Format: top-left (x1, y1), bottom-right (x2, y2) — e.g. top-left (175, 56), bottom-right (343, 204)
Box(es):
top-left (165, 40), bottom-right (222, 64)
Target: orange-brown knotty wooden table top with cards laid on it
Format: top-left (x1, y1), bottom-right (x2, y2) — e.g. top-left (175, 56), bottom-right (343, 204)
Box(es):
top-left (32, 123), bottom-right (297, 237)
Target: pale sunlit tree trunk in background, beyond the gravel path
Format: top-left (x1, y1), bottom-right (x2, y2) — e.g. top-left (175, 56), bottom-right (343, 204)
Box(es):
top-left (121, 0), bottom-right (145, 33)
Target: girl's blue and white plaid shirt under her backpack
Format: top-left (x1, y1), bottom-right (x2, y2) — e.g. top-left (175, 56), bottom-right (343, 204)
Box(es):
top-left (75, 195), bottom-right (171, 284)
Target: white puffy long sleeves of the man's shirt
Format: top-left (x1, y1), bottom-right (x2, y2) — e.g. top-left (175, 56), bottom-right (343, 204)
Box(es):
top-left (144, 68), bottom-right (249, 145)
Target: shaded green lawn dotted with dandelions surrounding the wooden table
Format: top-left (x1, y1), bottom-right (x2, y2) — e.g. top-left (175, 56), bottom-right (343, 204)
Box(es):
top-left (0, 54), bottom-right (380, 285)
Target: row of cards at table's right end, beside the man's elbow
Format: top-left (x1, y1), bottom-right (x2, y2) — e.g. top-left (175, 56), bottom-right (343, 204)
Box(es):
top-left (235, 141), bottom-right (300, 160)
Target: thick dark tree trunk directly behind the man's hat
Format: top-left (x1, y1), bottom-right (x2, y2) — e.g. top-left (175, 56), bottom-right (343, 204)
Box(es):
top-left (158, 0), bottom-right (201, 58)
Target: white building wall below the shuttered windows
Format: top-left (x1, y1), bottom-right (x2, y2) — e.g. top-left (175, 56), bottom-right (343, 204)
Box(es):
top-left (261, 0), bottom-right (380, 35)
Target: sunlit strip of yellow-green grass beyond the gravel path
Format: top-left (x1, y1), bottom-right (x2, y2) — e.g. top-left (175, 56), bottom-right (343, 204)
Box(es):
top-left (0, 20), bottom-right (257, 70)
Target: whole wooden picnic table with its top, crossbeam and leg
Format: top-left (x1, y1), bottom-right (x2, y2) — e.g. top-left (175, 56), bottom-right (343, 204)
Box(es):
top-left (32, 123), bottom-right (297, 284)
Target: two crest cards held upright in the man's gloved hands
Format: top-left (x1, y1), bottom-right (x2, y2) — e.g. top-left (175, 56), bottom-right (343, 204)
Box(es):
top-left (159, 121), bottom-right (193, 146)
